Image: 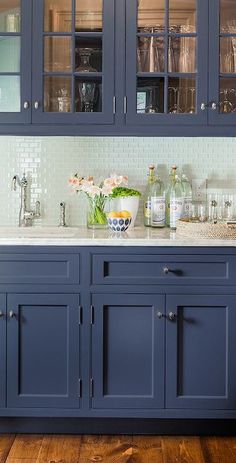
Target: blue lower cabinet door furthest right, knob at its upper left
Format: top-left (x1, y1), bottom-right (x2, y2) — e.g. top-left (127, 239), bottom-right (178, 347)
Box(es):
top-left (166, 295), bottom-right (236, 410)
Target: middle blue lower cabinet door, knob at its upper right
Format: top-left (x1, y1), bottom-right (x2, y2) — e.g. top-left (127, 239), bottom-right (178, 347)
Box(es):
top-left (92, 294), bottom-right (165, 415)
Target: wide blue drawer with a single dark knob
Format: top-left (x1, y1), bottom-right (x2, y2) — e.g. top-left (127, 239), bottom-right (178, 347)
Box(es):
top-left (92, 254), bottom-right (236, 285)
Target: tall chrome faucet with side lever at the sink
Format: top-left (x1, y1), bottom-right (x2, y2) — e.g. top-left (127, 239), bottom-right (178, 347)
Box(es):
top-left (12, 173), bottom-right (41, 227)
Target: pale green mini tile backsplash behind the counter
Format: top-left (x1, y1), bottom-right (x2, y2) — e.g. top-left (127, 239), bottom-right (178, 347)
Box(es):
top-left (0, 137), bottom-right (236, 226)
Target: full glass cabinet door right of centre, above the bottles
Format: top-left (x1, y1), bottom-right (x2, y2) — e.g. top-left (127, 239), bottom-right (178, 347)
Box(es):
top-left (126, 0), bottom-right (208, 125)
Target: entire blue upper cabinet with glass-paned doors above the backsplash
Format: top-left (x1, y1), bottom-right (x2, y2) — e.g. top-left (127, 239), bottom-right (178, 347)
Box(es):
top-left (0, 0), bottom-right (236, 136)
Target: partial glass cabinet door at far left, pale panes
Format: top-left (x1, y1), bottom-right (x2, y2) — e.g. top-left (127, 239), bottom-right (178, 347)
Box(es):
top-left (0, 0), bottom-right (31, 124)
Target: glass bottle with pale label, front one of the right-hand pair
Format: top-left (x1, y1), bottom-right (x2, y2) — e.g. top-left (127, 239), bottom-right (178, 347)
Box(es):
top-left (166, 166), bottom-right (184, 230)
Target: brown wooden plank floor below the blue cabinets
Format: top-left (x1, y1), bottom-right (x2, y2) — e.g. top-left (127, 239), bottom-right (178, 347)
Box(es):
top-left (0, 435), bottom-right (236, 463)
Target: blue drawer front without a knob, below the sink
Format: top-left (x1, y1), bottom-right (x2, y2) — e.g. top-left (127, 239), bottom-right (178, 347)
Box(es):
top-left (0, 254), bottom-right (80, 284)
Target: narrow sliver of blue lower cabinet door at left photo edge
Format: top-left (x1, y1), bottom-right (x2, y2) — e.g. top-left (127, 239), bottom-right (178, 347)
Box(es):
top-left (0, 294), bottom-right (7, 407)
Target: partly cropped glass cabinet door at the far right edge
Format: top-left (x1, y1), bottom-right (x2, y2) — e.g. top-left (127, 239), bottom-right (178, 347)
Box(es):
top-left (209, 0), bottom-right (236, 125)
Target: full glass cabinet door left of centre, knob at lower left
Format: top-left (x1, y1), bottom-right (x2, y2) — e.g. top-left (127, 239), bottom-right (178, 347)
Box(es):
top-left (33, 0), bottom-right (114, 124)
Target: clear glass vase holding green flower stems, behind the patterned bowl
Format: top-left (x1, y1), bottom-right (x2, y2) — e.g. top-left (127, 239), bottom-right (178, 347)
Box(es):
top-left (87, 197), bottom-right (107, 229)
